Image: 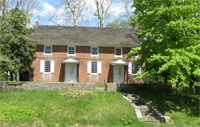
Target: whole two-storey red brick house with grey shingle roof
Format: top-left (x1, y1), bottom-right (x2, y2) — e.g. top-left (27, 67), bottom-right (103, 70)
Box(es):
top-left (29, 26), bottom-right (144, 83)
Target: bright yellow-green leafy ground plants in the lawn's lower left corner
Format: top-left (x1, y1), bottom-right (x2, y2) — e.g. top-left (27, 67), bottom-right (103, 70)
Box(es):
top-left (0, 104), bottom-right (40, 124)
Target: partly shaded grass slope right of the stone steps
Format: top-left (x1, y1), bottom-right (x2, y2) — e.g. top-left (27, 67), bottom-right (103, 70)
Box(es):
top-left (130, 91), bottom-right (200, 126)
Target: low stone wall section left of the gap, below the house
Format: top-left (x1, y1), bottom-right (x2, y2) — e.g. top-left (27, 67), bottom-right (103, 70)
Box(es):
top-left (0, 82), bottom-right (95, 90)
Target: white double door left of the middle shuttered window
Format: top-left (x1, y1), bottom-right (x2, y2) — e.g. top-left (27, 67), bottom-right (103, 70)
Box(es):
top-left (65, 63), bottom-right (77, 82)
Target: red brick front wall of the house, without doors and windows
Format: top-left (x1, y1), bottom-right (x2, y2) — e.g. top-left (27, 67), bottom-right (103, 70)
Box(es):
top-left (30, 45), bottom-right (144, 83)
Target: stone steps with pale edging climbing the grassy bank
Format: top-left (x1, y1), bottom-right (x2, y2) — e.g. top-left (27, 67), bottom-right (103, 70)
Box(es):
top-left (122, 94), bottom-right (159, 123)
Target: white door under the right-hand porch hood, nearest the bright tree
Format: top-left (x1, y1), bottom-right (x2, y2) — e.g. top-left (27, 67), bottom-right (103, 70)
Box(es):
top-left (113, 65), bottom-right (124, 83)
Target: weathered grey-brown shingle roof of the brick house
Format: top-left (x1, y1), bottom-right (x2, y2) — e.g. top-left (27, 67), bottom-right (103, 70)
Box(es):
top-left (29, 26), bottom-right (142, 45)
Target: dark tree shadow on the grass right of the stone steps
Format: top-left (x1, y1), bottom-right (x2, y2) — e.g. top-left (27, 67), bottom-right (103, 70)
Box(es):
top-left (124, 91), bottom-right (200, 117)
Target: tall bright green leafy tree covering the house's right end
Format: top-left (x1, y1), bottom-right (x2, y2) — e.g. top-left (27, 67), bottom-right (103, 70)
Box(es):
top-left (129, 0), bottom-right (200, 87)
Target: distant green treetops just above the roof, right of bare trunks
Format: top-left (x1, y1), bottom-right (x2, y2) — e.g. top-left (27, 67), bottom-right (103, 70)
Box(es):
top-left (106, 19), bottom-right (131, 28)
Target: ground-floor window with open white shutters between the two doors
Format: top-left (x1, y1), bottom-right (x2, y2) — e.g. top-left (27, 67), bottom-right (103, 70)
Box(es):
top-left (87, 61), bottom-right (101, 74)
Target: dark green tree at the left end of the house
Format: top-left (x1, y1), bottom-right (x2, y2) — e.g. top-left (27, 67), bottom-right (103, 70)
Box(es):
top-left (0, 6), bottom-right (35, 80)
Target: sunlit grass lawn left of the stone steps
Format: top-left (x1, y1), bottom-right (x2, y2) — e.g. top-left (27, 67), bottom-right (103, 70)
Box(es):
top-left (0, 90), bottom-right (145, 126)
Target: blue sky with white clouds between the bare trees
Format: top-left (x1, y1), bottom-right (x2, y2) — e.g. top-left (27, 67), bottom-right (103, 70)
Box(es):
top-left (28, 0), bottom-right (134, 27)
